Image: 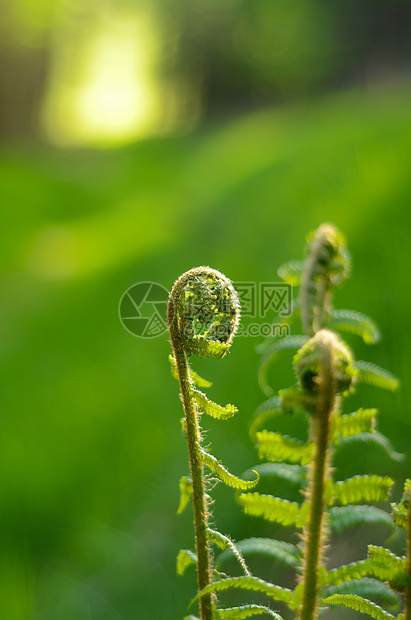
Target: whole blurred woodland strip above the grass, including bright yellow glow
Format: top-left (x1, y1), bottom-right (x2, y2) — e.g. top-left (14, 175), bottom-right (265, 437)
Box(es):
top-left (0, 0), bottom-right (411, 145)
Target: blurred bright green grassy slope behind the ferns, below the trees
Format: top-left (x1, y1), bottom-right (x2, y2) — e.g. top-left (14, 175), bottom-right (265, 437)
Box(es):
top-left (0, 86), bottom-right (411, 620)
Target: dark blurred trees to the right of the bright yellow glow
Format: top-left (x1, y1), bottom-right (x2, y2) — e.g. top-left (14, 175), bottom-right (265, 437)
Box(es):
top-left (157, 0), bottom-right (411, 114)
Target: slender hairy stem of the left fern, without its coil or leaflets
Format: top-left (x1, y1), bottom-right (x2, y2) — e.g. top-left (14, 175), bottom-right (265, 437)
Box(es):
top-left (168, 305), bottom-right (212, 620)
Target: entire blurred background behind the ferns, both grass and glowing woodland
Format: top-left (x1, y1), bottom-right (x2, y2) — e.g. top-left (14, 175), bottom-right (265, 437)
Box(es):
top-left (0, 0), bottom-right (411, 620)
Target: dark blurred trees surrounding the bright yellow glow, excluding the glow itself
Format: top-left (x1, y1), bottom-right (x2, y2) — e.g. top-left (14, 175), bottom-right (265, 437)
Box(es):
top-left (0, 0), bottom-right (411, 140)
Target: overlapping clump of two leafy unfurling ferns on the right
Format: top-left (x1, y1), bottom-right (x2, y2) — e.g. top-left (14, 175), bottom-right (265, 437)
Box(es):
top-left (203, 224), bottom-right (408, 620)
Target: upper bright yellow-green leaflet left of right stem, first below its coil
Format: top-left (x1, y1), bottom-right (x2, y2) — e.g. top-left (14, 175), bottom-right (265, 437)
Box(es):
top-left (257, 430), bottom-right (314, 465)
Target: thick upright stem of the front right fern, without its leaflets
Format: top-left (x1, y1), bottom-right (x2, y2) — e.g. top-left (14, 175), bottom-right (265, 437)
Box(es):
top-left (300, 334), bottom-right (336, 620)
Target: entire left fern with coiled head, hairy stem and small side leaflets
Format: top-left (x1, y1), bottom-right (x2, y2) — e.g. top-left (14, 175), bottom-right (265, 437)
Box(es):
top-left (167, 267), bottom-right (279, 620)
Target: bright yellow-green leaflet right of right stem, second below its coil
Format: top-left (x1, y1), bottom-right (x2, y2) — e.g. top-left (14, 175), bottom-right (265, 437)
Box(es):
top-left (326, 474), bottom-right (394, 506)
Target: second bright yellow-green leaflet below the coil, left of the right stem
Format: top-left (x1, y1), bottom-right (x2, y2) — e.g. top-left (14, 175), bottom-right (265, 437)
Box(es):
top-left (239, 493), bottom-right (304, 527)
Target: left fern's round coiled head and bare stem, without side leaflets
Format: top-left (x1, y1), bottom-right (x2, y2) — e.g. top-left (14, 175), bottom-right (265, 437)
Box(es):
top-left (167, 267), bottom-right (240, 620)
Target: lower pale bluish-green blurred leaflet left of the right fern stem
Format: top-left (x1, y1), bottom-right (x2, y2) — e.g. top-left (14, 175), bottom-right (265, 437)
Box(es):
top-left (216, 538), bottom-right (301, 566)
